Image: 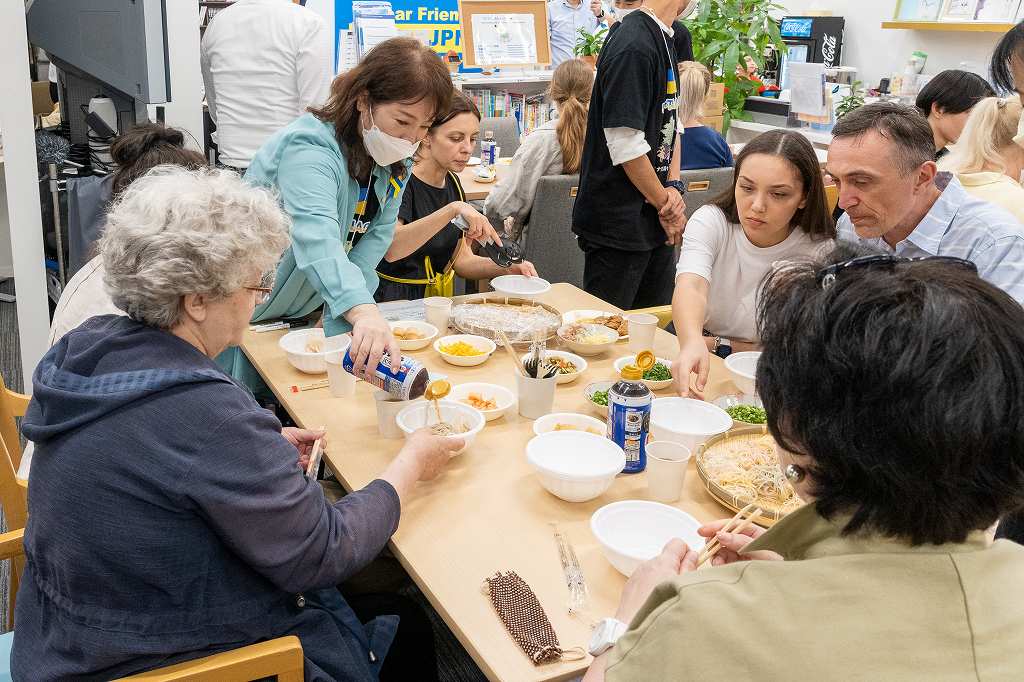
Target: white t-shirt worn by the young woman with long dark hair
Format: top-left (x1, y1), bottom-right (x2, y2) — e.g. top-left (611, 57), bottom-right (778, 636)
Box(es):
top-left (676, 205), bottom-right (831, 342)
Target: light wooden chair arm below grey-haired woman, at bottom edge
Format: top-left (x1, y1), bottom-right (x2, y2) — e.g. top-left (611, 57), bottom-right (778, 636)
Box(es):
top-left (121, 635), bottom-right (304, 682)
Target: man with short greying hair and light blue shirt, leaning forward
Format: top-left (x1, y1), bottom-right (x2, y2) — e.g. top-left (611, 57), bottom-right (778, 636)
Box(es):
top-left (827, 102), bottom-right (1024, 303)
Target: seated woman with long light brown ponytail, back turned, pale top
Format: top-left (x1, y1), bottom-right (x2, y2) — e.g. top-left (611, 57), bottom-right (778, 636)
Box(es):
top-left (483, 59), bottom-right (594, 238)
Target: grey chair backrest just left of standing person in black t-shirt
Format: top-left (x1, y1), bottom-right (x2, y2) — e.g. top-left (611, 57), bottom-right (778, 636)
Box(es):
top-left (522, 175), bottom-right (584, 289)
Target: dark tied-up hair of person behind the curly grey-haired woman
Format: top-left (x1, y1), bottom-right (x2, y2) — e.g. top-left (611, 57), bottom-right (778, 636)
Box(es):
top-left (111, 123), bottom-right (208, 201)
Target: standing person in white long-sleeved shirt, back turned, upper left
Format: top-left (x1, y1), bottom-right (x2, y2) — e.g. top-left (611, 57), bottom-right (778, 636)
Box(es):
top-left (200, 0), bottom-right (334, 171)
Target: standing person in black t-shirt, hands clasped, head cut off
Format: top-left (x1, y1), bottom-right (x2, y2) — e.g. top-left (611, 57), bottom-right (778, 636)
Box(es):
top-left (572, 0), bottom-right (689, 309)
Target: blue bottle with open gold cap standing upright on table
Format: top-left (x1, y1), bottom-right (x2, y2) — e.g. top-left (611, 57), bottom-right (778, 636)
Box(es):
top-left (608, 350), bottom-right (654, 473)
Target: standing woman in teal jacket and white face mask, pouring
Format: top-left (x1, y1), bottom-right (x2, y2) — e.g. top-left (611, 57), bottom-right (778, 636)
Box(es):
top-left (231, 38), bottom-right (453, 378)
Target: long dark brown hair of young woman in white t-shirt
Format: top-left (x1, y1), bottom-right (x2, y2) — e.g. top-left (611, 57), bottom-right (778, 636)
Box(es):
top-left (714, 130), bottom-right (836, 240)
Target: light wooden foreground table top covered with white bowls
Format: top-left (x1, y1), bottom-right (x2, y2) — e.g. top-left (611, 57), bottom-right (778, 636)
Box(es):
top-left (242, 284), bottom-right (734, 682)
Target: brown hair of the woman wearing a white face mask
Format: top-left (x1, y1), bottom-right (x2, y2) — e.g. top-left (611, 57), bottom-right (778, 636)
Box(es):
top-left (309, 38), bottom-right (453, 178)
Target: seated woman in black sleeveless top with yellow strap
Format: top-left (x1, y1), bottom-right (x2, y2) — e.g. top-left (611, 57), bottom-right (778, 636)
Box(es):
top-left (374, 91), bottom-right (537, 302)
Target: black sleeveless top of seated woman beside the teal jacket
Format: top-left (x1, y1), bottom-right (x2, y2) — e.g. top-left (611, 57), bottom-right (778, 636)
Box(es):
top-left (374, 173), bottom-right (462, 302)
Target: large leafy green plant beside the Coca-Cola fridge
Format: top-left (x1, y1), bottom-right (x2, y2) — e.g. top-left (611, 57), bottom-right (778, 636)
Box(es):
top-left (686, 0), bottom-right (785, 133)
